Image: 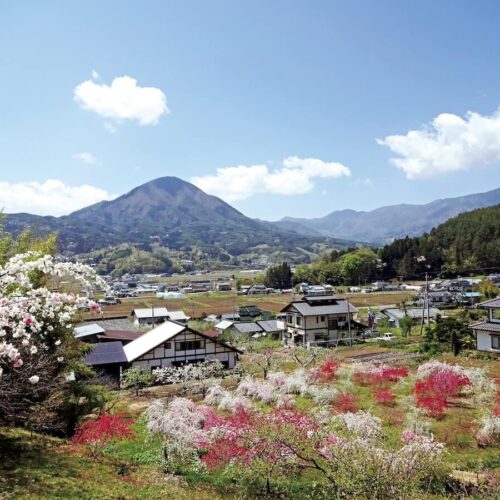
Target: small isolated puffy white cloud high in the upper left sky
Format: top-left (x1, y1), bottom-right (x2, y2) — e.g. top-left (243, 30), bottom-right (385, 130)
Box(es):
top-left (73, 76), bottom-right (169, 125)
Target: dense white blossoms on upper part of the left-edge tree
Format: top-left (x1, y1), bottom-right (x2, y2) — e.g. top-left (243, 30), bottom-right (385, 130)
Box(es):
top-left (0, 252), bottom-right (106, 384)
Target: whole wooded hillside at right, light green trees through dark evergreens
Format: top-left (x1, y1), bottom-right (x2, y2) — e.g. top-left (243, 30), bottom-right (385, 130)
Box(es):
top-left (294, 205), bottom-right (500, 285)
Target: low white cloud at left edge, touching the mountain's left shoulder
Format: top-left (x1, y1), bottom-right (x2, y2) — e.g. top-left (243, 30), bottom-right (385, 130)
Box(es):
top-left (0, 179), bottom-right (115, 215)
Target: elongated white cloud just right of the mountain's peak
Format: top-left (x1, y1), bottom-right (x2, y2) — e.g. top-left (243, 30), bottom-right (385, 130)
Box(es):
top-left (191, 156), bottom-right (351, 202)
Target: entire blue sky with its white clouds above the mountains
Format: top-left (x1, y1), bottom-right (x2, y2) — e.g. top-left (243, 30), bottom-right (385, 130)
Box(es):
top-left (0, 0), bottom-right (500, 220)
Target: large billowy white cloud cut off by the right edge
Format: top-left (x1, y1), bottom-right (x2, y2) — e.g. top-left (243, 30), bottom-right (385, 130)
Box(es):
top-left (377, 110), bottom-right (500, 179)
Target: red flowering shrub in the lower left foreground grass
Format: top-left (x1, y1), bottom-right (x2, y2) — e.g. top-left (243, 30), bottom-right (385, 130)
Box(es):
top-left (71, 413), bottom-right (134, 444)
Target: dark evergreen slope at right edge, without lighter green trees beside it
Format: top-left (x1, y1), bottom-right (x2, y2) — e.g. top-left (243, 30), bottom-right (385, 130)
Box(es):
top-left (379, 205), bottom-right (500, 278)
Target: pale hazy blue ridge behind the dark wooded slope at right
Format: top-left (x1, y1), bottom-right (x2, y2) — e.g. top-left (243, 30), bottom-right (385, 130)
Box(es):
top-left (274, 188), bottom-right (500, 245)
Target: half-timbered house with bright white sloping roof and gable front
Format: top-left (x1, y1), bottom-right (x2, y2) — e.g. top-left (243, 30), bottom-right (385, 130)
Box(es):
top-left (123, 321), bottom-right (240, 370)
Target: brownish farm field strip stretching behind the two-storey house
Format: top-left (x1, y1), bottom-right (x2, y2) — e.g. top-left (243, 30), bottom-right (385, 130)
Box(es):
top-left (95, 292), bottom-right (412, 318)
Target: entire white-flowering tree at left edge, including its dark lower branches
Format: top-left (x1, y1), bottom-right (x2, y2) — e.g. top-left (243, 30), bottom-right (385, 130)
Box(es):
top-left (0, 252), bottom-right (106, 424)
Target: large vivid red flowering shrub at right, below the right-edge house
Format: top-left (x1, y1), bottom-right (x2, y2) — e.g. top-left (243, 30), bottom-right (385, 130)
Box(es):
top-left (415, 370), bottom-right (470, 417)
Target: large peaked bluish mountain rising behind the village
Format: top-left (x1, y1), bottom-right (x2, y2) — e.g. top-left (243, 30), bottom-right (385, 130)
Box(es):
top-left (5, 177), bottom-right (355, 260)
